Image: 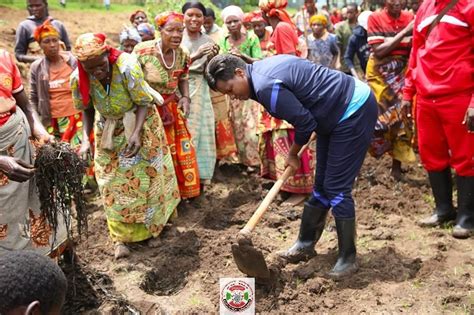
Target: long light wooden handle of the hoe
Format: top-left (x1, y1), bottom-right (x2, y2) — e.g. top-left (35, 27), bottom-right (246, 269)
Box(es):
top-left (239, 133), bottom-right (316, 234)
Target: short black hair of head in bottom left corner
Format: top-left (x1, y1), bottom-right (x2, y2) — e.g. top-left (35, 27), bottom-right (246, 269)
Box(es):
top-left (0, 250), bottom-right (67, 314)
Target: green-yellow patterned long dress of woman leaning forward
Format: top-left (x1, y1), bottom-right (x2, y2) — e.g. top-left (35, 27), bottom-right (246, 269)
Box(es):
top-left (71, 53), bottom-right (180, 242)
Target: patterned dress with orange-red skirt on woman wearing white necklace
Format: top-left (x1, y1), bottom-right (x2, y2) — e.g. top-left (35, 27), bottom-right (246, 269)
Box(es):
top-left (133, 40), bottom-right (200, 199)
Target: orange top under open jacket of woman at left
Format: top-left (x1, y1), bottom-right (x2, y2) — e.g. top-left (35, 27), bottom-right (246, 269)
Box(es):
top-left (49, 60), bottom-right (79, 118)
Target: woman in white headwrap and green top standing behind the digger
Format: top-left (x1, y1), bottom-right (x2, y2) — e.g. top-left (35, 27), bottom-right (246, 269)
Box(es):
top-left (219, 5), bottom-right (262, 167)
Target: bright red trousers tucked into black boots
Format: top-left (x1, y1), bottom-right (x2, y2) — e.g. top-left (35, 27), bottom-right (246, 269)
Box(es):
top-left (416, 93), bottom-right (474, 176)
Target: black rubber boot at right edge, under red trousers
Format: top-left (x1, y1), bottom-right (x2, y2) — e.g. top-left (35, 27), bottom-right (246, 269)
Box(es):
top-left (453, 176), bottom-right (474, 238)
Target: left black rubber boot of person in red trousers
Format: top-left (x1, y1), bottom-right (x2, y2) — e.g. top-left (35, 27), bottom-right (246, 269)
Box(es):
top-left (418, 167), bottom-right (456, 227)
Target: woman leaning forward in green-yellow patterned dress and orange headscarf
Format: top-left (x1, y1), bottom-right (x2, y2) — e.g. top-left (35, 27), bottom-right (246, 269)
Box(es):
top-left (71, 33), bottom-right (180, 258)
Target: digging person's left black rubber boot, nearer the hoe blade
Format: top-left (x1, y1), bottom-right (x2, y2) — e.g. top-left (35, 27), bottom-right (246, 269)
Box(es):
top-left (280, 202), bottom-right (329, 263)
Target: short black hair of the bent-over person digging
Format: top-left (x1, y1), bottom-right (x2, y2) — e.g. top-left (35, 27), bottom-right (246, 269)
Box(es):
top-left (204, 54), bottom-right (246, 90)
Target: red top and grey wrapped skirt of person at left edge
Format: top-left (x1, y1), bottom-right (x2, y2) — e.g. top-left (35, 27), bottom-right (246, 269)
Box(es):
top-left (0, 49), bottom-right (67, 257)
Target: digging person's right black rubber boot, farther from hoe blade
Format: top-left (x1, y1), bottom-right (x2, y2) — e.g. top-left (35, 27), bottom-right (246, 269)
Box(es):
top-left (328, 218), bottom-right (359, 280)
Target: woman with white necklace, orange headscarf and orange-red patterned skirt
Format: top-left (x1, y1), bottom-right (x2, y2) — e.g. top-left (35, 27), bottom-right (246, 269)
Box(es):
top-left (133, 12), bottom-right (200, 199)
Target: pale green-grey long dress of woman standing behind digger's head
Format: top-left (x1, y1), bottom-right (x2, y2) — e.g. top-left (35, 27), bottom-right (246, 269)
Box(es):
top-left (182, 31), bottom-right (216, 183)
